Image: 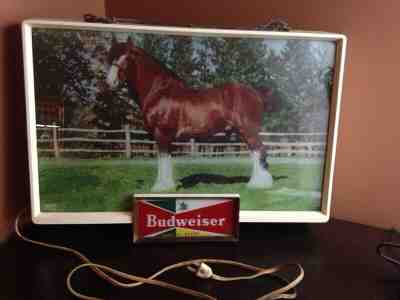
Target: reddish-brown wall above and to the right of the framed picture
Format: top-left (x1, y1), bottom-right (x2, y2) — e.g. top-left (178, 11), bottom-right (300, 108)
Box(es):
top-left (105, 0), bottom-right (400, 227)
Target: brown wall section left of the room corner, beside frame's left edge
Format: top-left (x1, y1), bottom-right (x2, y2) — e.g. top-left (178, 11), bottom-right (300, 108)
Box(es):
top-left (0, 0), bottom-right (104, 241)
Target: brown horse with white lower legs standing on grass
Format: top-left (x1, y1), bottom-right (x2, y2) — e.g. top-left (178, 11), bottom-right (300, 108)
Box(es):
top-left (107, 39), bottom-right (272, 190)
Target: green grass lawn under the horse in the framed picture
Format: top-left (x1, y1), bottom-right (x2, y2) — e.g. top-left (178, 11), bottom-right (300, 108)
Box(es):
top-left (39, 158), bottom-right (322, 212)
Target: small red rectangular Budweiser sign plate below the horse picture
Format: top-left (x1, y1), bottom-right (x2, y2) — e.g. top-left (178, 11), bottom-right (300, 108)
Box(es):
top-left (133, 194), bottom-right (239, 242)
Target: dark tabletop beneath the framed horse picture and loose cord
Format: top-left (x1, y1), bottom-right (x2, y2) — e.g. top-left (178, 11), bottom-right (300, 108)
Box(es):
top-left (0, 220), bottom-right (400, 300)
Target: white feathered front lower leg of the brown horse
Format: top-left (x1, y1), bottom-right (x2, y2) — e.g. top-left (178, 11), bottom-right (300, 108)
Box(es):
top-left (151, 152), bottom-right (175, 192)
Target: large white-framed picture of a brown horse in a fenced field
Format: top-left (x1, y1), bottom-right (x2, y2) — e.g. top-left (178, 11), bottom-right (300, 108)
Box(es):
top-left (22, 20), bottom-right (346, 225)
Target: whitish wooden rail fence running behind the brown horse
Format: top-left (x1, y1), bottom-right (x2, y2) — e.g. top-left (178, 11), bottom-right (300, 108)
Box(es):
top-left (36, 125), bottom-right (326, 158)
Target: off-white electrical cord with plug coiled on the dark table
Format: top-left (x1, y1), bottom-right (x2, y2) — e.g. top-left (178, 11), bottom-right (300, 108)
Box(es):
top-left (15, 211), bottom-right (304, 300)
